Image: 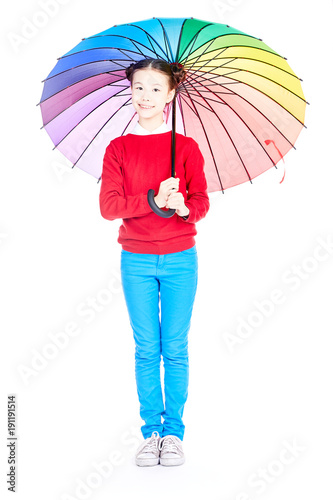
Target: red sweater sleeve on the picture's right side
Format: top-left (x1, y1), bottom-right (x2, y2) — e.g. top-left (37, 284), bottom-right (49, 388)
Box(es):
top-left (183, 137), bottom-right (210, 223)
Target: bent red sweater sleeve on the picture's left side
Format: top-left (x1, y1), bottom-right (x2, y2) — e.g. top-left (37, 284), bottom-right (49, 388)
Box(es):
top-left (99, 141), bottom-right (152, 220)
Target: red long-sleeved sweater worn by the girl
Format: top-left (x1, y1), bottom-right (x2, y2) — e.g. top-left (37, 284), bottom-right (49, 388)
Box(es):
top-left (99, 131), bottom-right (210, 255)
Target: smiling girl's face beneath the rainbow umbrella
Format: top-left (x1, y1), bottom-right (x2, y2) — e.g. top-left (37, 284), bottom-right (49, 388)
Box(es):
top-left (131, 68), bottom-right (175, 122)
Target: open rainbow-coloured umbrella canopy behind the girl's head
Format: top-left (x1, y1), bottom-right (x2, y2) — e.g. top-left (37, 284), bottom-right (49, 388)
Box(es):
top-left (39, 18), bottom-right (307, 192)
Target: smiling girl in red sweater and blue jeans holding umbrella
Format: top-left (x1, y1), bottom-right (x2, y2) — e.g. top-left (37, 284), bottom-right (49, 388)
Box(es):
top-left (100, 59), bottom-right (210, 466)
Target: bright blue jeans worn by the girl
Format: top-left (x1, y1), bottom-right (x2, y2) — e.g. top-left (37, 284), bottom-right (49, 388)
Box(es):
top-left (120, 245), bottom-right (198, 440)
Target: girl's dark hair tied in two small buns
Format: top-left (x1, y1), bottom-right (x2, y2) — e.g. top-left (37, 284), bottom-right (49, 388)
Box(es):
top-left (125, 58), bottom-right (186, 90)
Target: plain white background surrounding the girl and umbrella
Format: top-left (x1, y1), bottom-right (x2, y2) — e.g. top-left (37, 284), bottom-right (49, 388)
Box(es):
top-left (0, 0), bottom-right (333, 500)
